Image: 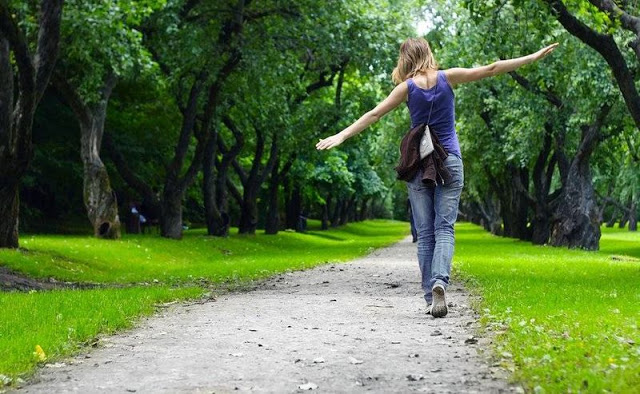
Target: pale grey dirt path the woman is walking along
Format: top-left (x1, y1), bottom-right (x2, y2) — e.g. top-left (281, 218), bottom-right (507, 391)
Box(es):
top-left (17, 235), bottom-right (516, 393)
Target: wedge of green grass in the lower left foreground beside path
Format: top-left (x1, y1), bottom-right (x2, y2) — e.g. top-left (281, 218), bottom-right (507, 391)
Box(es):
top-left (0, 286), bottom-right (203, 387)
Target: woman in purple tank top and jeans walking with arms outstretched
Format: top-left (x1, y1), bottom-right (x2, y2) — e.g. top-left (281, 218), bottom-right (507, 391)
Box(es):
top-left (316, 38), bottom-right (558, 317)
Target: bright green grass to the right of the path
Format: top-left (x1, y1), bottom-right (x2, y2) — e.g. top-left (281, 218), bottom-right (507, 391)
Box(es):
top-left (454, 224), bottom-right (640, 393)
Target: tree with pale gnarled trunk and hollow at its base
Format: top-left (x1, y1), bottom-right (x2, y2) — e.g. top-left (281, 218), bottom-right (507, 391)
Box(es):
top-left (52, 0), bottom-right (163, 238)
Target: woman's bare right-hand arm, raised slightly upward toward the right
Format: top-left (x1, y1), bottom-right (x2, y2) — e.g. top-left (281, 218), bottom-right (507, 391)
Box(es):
top-left (444, 43), bottom-right (558, 85)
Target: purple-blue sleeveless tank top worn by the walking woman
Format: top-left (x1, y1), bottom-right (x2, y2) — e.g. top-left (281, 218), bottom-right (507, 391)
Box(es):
top-left (407, 70), bottom-right (462, 158)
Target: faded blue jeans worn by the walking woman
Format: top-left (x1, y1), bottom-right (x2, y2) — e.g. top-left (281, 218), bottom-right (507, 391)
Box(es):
top-left (407, 154), bottom-right (464, 303)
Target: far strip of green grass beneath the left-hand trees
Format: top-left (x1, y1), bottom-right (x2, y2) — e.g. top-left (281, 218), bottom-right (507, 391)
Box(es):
top-left (0, 220), bottom-right (408, 284)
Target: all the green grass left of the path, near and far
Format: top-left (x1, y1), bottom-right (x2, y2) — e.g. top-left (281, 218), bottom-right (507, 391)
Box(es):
top-left (0, 220), bottom-right (409, 387)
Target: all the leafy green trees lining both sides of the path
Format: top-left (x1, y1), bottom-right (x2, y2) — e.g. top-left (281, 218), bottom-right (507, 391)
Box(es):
top-left (0, 0), bottom-right (640, 249)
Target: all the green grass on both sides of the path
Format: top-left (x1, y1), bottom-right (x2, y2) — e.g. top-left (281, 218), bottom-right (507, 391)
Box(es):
top-left (5, 220), bottom-right (640, 393)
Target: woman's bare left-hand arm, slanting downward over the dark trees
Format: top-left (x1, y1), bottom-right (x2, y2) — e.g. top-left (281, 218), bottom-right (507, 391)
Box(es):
top-left (316, 82), bottom-right (409, 150)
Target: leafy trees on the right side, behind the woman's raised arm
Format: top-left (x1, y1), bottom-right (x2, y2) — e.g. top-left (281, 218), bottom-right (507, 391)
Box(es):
top-left (433, 0), bottom-right (640, 249)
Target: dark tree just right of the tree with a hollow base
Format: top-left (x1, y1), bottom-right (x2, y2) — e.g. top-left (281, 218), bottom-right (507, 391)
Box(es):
top-left (145, 0), bottom-right (248, 239)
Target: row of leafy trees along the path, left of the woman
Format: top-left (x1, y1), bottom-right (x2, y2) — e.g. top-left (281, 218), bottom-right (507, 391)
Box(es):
top-left (0, 0), bottom-right (413, 247)
